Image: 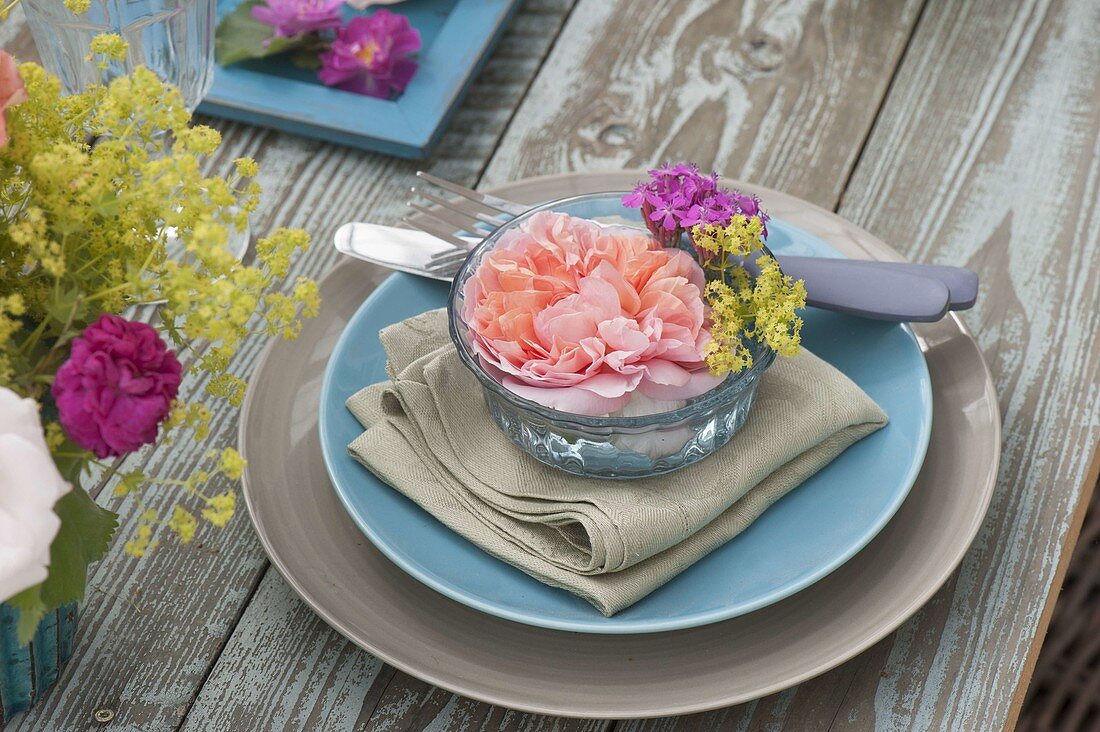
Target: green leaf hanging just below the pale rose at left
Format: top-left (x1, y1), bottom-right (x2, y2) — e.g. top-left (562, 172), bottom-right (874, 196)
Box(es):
top-left (41, 485), bottom-right (118, 610)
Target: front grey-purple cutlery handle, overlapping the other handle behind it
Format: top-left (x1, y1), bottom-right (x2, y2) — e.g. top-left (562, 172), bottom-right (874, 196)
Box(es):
top-left (777, 256), bottom-right (950, 323)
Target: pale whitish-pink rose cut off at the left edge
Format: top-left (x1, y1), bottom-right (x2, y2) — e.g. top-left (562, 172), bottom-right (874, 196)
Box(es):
top-left (0, 386), bottom-right (70, 601)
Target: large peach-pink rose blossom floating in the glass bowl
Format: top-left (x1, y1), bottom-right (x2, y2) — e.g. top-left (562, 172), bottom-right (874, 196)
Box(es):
top-left (463, 212), bottom-right (722, 415)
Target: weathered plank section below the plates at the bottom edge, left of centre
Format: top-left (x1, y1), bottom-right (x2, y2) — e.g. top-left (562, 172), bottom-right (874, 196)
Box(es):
top-left (183, 570), bottom-right (607, 732)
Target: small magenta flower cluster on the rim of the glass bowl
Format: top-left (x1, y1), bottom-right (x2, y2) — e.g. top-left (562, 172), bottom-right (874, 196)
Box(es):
top-left (623, 163), bottom-right (768, 245)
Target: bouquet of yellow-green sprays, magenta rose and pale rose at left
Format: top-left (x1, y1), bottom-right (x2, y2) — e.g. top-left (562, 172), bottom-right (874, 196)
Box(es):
top-left (0, 35), bottom-right (318, 712)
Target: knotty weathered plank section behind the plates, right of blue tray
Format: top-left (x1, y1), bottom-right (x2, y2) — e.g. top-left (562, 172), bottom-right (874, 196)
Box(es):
top-left (483, 0), bottom-right (922, 207)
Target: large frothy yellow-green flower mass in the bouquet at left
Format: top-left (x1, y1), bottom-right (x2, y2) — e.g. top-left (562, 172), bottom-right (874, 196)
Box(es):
top-left (0, 41), bottom-right (319, 555)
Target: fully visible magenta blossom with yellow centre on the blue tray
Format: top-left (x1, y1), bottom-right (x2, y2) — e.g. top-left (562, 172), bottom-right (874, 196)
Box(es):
top-left (317, 9), bottom-right (420, 99)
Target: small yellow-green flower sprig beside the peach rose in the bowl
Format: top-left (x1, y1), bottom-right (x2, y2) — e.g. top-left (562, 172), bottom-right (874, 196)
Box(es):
top-left (692, 214), bottom-right (806, 375)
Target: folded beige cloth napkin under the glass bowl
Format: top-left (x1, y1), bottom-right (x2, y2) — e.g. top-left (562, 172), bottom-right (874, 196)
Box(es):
top-left (348, 310), bottom-right (887, 615)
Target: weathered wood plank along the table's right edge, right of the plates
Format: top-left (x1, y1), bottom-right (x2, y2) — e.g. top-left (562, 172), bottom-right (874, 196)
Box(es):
top-left (624, 0), bottom-right (1100, 730)
